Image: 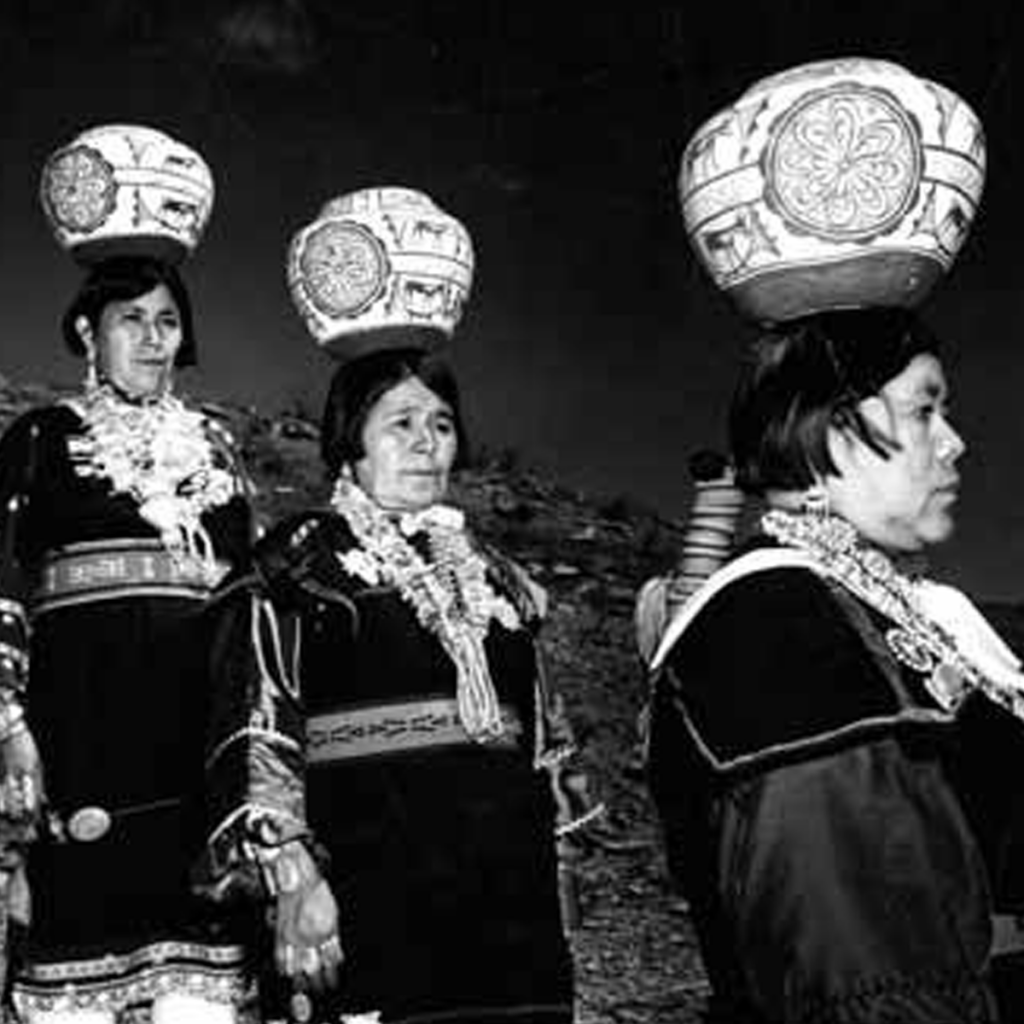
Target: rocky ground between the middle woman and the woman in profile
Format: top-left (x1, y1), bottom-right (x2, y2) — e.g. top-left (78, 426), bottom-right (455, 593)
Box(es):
top-left (448, 469), bottom-right (707, 1024)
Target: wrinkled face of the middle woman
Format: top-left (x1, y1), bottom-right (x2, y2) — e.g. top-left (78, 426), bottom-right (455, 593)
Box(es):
top-left (355, 377), bottom-right (458, 512)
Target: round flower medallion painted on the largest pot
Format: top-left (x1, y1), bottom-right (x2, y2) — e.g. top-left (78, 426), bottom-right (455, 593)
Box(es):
top-left (764, 83), bottom-right (923, 241)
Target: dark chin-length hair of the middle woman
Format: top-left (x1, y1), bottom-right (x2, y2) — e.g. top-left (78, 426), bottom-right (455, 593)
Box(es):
top-left (321, 348), bottom-right (468, 476)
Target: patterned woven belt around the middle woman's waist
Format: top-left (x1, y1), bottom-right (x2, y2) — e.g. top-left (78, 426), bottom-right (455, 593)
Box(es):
top-left (306, 698), bottom-right (522, 764)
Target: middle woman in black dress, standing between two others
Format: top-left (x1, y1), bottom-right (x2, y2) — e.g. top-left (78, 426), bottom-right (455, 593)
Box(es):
top-left (197, 344), bottom-right (593, 1024)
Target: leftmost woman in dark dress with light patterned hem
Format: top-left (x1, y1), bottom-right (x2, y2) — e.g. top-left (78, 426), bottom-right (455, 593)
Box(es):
top-left (0, 249), bottom-right (251, 1024)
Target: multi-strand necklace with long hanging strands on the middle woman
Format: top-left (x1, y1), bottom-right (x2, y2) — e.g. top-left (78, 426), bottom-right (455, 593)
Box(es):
top-left (331, 477), bottom-right (520, 742)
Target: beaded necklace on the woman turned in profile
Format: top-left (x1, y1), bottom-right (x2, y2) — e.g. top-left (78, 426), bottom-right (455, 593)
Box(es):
top-left (761, 509), bottom-right (1024, 718)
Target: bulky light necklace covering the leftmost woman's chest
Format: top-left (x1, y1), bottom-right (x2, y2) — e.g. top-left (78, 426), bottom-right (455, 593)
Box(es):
top-left (67, 384), bottom-right (239, 574)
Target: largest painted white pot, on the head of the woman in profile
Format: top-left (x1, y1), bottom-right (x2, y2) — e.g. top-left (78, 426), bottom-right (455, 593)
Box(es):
top-left (679, 58), bottom-right (985, 323)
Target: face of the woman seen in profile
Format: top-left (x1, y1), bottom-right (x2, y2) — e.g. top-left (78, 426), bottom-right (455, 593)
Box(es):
top-left (824, 354), bottom-right (965, 552)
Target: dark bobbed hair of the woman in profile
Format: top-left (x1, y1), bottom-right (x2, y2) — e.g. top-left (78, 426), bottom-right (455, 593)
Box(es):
top-left (729, 308), bottom-right (939, 494)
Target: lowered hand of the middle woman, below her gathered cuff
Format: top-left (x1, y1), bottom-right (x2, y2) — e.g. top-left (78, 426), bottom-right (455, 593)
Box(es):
top-left (273, 850), bottom-right (344, 992)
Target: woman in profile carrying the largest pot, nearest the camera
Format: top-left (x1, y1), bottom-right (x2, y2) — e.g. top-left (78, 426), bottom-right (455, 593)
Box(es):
top-left (650, 309), bottom-right (1024, 1022)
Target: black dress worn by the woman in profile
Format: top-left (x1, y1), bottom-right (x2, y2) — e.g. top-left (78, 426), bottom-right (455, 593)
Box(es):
top-left (650, 536), bottom-right (996, 1024)
